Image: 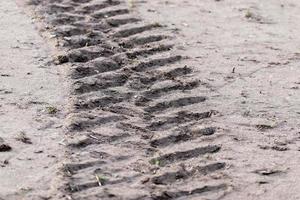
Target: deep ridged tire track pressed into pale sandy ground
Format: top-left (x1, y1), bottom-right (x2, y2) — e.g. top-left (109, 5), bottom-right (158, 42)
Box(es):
top-left (31, 0), bottom-right (229, 200)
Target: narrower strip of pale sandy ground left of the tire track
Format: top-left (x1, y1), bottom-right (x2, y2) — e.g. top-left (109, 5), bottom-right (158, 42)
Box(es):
top-left (0, 1), bottom-right (67, 200)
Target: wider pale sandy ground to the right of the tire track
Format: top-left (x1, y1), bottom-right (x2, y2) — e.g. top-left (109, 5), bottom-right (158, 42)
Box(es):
top-left (138, 0), bottom-right (300, 199)
